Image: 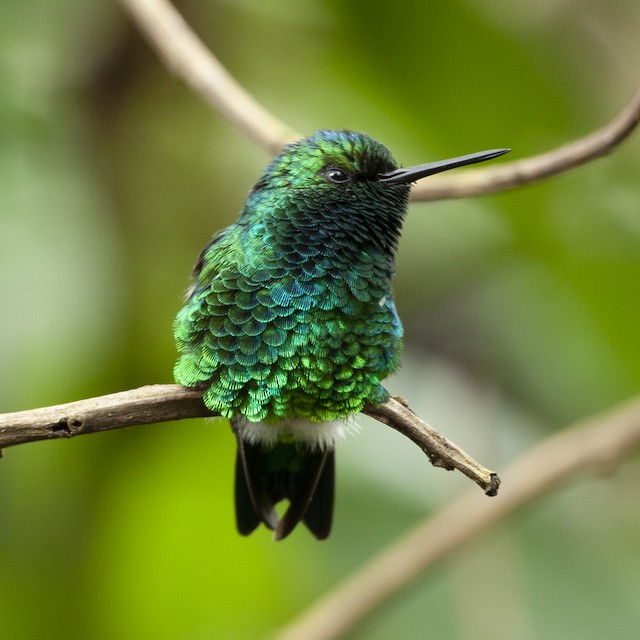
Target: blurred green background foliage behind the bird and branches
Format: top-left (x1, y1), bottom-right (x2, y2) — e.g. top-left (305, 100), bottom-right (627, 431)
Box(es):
top-left (0, 0), bottom-right (640, 640)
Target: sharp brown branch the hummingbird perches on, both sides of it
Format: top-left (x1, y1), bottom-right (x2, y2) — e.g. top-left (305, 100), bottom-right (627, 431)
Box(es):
top-left (0, 384), bottom-right (500, 496)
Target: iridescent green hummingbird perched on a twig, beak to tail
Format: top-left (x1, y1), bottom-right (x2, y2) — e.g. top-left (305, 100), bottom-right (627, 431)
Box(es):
top-left (174, 130), bottom-right (509, 540)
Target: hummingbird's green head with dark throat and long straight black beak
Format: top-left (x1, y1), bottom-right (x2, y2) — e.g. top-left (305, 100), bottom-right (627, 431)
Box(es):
top-left (249, 130), bottom-right (507, 252)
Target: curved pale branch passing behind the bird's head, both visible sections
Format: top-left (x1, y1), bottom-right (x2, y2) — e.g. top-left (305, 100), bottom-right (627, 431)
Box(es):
top-left (120, 0), bottom-right (640, 202)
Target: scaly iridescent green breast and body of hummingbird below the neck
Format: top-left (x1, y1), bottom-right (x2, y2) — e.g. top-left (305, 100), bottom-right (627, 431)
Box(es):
top-left (174, 222), bottom-right (402, 422)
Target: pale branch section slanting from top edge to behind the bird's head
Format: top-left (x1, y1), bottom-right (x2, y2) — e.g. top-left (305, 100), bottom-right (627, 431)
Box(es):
top-left (120, 0), bottom-right (301, 155)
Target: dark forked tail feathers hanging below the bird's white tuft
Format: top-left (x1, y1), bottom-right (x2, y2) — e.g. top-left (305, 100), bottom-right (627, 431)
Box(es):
top-left (235, 434), bottom-right (335, 540)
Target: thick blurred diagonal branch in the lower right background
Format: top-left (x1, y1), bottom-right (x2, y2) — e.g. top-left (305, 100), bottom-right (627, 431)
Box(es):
top-left (275, 398), bottom-right (640, 640)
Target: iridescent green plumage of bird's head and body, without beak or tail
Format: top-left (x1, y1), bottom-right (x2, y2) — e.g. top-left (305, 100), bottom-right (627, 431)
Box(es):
top-left (175, 132), bottom-right (409, 422)
